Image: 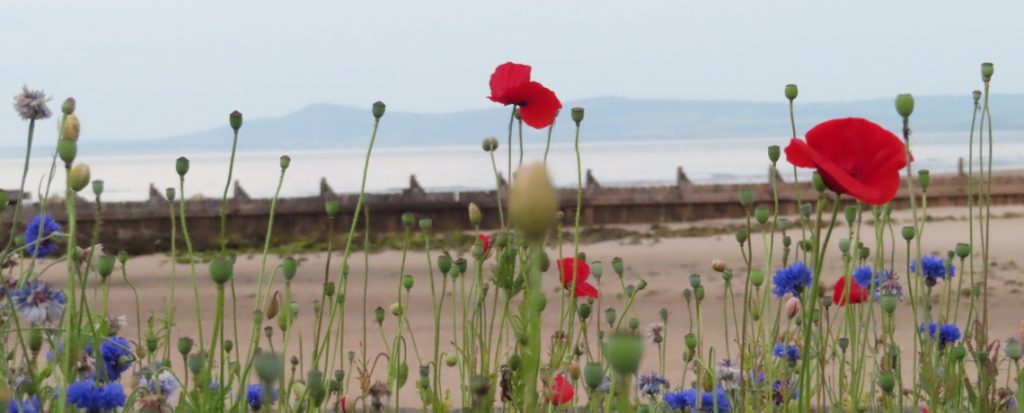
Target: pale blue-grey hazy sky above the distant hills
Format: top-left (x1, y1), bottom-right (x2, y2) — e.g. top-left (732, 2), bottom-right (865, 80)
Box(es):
top-left (0, 0), bottom-right (1024, 142)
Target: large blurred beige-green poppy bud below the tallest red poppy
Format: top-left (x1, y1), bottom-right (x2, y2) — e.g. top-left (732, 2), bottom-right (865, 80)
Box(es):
top-left (509, 163), bottom-right (558, 240)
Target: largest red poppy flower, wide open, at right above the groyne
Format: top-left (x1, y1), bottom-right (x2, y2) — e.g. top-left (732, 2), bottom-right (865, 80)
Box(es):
top-left (785, 118), bottom-right (906, 205)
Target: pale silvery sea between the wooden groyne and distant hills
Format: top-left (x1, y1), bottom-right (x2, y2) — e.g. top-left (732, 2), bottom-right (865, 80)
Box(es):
top-left (0, 131), bottom-right (1024, 201)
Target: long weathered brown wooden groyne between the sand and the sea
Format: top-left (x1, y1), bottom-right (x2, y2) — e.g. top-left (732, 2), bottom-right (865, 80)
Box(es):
top-left (0, 168), bottom-right (1024, 254)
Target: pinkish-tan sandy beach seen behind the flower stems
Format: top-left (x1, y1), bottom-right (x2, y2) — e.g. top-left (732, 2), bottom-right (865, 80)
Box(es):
top-left (29, 206), bottom-right (1024, 404)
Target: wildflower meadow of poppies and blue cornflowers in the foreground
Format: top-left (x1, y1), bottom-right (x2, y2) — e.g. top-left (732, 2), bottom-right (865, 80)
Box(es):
top-left (0, 63), bottom-right (1024, 413)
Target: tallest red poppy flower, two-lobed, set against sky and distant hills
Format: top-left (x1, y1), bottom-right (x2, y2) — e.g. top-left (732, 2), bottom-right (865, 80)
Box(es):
top-left (488, 61), bottom-right (562, 129)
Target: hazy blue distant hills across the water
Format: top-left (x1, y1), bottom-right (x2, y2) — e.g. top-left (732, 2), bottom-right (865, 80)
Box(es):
top-left (44, 94), bottom-right (1024, 154)
